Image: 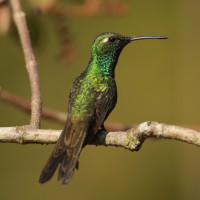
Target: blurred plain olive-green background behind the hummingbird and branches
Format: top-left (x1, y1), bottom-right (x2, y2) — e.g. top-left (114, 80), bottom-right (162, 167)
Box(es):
top-left (0, 0), bottom-right (200, 200)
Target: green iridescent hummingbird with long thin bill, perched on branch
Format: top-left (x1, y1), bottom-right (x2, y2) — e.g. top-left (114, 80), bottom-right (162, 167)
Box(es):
top-left (39, 32), bottom-right (167, 184)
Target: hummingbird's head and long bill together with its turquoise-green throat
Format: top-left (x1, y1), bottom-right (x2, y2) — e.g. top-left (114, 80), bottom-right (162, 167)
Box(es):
top-left (88, 32), bottom-right (167, 77)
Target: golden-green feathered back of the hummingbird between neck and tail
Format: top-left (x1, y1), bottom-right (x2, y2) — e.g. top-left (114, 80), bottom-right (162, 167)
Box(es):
top-left (68, 66), bottom-right (116, 120)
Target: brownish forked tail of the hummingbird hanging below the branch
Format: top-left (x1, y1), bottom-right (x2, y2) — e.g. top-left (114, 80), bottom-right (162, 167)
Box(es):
top-left (39, 120), bottom-right (88, 184)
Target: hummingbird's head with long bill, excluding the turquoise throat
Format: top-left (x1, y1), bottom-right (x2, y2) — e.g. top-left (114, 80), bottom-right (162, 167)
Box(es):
top-left (92, 32), bottom-right (167, 57)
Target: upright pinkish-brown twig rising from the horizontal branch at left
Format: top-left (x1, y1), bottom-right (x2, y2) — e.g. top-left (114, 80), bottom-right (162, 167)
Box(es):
top-left (10, 0), bottom-right (42, 128)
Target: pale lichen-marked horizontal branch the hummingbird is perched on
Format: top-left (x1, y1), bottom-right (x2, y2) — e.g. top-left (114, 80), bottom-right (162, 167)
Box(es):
top-left (0, 122), bottom-right (200, 151)
